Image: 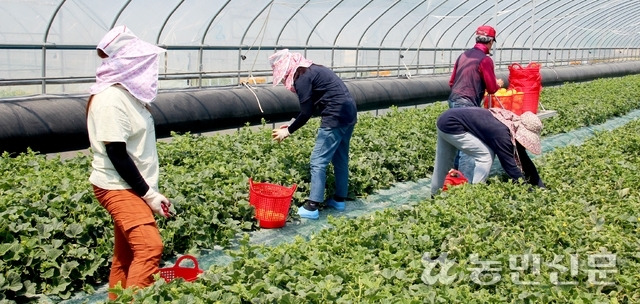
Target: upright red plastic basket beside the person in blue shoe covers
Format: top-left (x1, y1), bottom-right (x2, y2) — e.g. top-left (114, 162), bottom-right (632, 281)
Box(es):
top-left (249, 178), bottom-right (298, 228)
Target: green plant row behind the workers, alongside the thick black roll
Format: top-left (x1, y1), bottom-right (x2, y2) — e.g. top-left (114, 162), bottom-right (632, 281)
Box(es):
top-left (0, 76), bottom-right (640, 301)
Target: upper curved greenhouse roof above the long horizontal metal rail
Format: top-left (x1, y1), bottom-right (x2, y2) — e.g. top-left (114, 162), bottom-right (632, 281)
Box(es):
top-left (0, 0), bottom-right (640, 48)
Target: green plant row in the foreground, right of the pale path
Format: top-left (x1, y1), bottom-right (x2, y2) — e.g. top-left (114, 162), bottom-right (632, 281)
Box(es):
top-left (116, 116), bottom-right (640, 304)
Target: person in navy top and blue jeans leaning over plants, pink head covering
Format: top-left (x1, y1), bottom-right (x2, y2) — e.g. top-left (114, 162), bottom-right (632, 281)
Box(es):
top-left (269, 49), bottom-right (357, 219)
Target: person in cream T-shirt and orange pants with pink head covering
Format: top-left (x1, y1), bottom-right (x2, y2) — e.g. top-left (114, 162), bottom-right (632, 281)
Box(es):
top-left (87, 26), bottom-right (171, 300)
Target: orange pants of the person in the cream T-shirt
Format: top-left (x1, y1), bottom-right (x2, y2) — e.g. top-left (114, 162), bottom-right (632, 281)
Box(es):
top-left (93, 186), bottom-right (163, 300)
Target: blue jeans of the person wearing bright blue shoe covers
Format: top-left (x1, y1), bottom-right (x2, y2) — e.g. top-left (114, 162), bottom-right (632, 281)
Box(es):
top-left (309, 126), bottom-right (354, 202)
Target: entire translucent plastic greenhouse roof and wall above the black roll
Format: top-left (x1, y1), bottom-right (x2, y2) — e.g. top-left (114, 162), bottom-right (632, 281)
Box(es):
top-left (0, 0), bottom-right (640, 94)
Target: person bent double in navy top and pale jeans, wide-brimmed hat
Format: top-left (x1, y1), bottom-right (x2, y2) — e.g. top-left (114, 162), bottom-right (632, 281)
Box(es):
top-left (431, 107), bottom-right (545, 195)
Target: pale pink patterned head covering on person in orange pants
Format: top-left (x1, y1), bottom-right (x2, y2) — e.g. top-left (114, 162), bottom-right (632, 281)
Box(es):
top-left (90, 25), bottom-right (165, 103)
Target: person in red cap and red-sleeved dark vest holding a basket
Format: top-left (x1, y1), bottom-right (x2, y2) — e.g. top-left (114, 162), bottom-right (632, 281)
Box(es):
top-left (448, 25), bottom-right (504, 178)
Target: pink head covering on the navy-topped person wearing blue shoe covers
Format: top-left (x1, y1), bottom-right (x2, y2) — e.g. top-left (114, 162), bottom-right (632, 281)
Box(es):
top-left (269, 49), bottom-right (313, 93)
